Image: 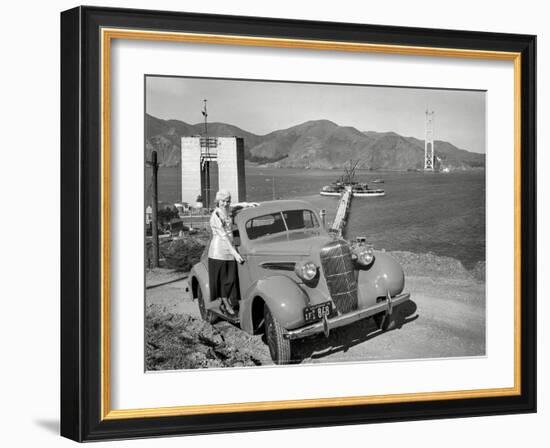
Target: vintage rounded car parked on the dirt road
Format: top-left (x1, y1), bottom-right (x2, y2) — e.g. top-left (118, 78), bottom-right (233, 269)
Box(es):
top-left (189, 200), bottom-right (409, 364)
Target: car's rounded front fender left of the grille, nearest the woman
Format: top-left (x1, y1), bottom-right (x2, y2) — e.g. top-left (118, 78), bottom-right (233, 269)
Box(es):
top-left (240, 275), bottom-right (309, 334)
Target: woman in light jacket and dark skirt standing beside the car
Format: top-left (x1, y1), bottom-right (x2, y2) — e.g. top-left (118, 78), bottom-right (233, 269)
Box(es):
top-left (208, 190), bottom-right (244, 316)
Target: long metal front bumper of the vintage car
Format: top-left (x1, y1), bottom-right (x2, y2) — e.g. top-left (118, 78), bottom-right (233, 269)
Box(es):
top-left (284, 293), bottom-right (411, 339)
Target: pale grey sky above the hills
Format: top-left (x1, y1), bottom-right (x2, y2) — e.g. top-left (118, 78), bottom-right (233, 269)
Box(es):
top-left (145, 76), bottom-right (486, 153)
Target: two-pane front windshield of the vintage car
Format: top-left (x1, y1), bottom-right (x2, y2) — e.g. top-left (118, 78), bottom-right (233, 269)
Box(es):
top-left (246, 210), bottom-right (319, 240)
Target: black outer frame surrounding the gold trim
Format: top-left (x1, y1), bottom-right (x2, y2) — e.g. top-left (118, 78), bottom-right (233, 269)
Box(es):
top-left (61, 7), bottom-right (536, 441)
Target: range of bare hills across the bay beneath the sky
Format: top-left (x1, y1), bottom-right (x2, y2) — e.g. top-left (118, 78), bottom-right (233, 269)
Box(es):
top-left (145, 115), bottom-right (485, 170)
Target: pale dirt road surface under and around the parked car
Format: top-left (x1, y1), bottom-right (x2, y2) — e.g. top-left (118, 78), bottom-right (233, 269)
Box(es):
top-left (146, 276), bottom-right (485, 363)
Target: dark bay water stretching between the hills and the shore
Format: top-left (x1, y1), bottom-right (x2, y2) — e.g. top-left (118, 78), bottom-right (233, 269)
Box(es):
top-left (146, 166), bottom-right (485, 268)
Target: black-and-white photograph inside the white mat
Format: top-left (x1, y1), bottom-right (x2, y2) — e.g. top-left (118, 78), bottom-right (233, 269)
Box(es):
top-left (144, 75), bottom-right (486, 371)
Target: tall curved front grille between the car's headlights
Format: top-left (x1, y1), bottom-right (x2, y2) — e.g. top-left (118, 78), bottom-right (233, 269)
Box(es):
top-left (321, 240), bottom-right (357, 313)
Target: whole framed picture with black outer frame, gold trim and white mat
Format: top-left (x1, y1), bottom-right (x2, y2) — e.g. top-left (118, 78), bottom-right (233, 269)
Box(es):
top-left (61, 7), bottom-right (536, 441)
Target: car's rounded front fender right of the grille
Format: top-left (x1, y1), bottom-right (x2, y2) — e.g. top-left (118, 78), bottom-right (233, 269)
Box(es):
top-left (357, 252), bottom-right (405, 308)
